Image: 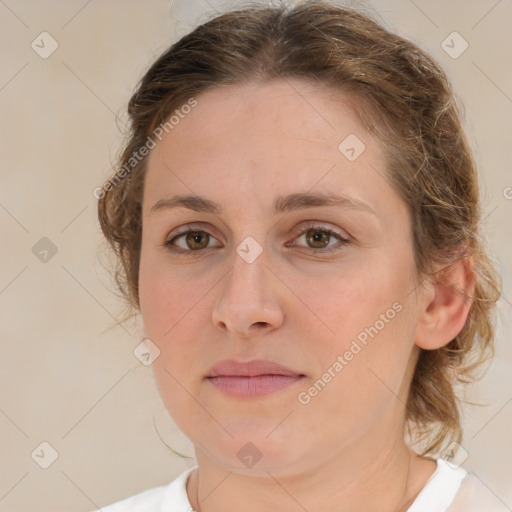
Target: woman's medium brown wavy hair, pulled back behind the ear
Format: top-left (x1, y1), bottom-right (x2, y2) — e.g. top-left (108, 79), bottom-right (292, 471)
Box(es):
top-left (98, 1), bottom-right (501, 454)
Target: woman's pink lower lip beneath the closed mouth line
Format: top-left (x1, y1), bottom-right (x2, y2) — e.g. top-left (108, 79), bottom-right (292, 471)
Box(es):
top-left (208, 375), bottom-right (302, 397)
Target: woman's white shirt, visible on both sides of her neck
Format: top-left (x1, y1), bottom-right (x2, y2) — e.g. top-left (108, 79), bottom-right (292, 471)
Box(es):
top-left (95, 459), bottom-right (510, 512)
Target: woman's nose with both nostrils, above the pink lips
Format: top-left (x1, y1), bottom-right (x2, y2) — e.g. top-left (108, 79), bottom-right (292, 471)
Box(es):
top-left (212, 245), bottom-right (284, 339)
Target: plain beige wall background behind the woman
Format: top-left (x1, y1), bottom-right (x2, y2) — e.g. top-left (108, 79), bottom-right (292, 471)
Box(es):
top-left (0, 0), bottom-right (512, 512)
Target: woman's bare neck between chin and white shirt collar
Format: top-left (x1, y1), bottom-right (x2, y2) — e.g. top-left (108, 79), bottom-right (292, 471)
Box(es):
top-left (187, 428), bottom-right (435, 512)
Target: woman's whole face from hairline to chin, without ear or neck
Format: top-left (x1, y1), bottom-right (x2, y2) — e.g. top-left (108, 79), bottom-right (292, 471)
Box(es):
top-left (139, 80), bottom-right (426, 474)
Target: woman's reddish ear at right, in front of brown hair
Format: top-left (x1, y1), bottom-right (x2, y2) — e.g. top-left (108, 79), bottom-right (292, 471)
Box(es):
top-left (415, 257), bottom-right (475, 350)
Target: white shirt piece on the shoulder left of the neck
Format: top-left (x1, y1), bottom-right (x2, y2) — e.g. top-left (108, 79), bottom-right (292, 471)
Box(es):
top-left (91, 467), bottom-right (196, 512)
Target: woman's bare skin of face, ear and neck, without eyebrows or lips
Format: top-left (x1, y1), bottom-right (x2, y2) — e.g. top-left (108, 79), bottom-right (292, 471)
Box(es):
top-left (139, 80), bottom-right (474, 512)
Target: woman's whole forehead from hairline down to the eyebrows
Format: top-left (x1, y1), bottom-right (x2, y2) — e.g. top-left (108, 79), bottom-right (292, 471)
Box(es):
top-left (140, 80), bottom-right (404, 230)
